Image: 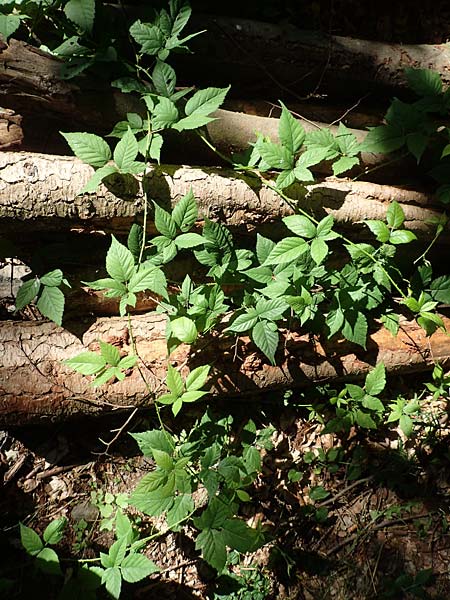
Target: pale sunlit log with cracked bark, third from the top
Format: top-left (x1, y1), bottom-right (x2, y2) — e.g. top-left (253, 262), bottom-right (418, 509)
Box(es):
top-left (0, 152), bottom-right (442, 241)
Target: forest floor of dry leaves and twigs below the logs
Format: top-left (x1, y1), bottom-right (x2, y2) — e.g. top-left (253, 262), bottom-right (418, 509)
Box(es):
top-left (0, 376), bottom-right (450, 600)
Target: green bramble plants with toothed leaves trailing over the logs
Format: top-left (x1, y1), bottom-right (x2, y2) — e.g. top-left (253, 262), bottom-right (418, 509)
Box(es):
top-left (0, 0), bottom-right (450, 600)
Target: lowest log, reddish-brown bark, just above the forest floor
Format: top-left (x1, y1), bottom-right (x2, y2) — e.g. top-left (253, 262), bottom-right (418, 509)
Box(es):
top-left (0, 314), bottom-right (450, 427)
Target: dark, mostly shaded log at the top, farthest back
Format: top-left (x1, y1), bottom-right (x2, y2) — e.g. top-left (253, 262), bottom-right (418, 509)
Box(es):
top-left (175, 15), bottom-right (450, 100)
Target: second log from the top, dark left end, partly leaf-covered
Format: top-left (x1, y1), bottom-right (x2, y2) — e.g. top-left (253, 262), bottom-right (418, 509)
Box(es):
top-left (0, 39), bottom-right (413, 176)
